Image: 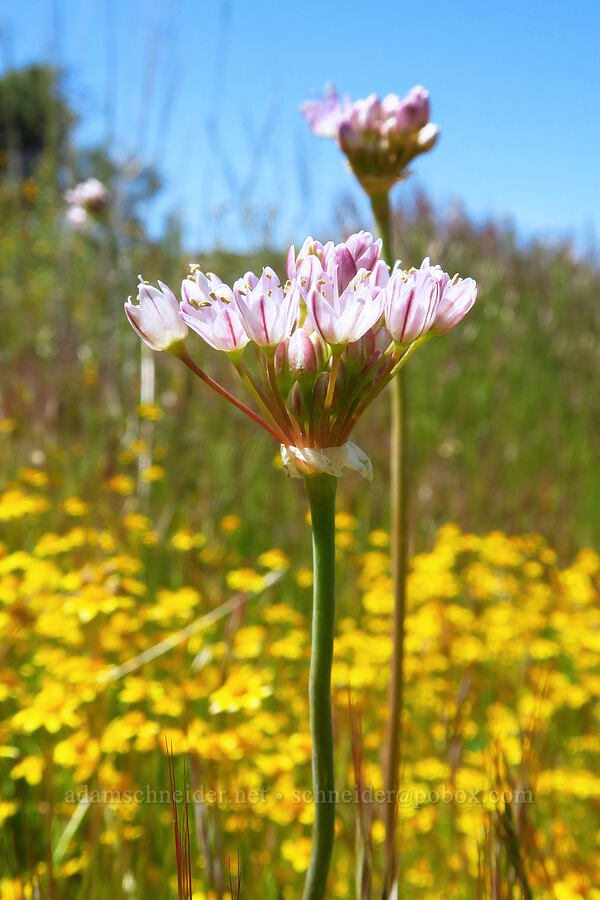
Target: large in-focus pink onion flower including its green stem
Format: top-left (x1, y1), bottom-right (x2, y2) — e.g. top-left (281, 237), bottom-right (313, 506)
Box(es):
top-left (125, 231), bottom-right (477, 900)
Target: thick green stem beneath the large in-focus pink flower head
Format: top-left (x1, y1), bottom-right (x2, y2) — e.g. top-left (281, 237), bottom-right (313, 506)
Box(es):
top-left (302, 475), bottom-right (337, 900)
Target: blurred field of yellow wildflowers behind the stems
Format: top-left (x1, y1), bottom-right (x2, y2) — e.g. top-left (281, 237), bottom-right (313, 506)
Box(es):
top-left (0, 469), bottom-right (600, 900)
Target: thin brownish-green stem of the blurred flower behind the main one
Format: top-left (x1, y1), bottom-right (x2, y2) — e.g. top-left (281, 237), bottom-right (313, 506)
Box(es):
top-left (370, 186), bottom-right (408, 896)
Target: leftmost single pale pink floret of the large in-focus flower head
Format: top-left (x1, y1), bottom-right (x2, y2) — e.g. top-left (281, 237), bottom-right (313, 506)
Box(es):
top-left (125, 281), bottom-right (187, 350)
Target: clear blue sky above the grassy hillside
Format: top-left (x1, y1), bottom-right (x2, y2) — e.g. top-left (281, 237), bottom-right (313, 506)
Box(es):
top-left (0, 0), bottom-right (600, 248)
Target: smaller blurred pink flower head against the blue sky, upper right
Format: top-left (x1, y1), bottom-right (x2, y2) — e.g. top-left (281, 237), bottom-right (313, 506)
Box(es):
top-left (301, 85), bottom-right (439, 196)
